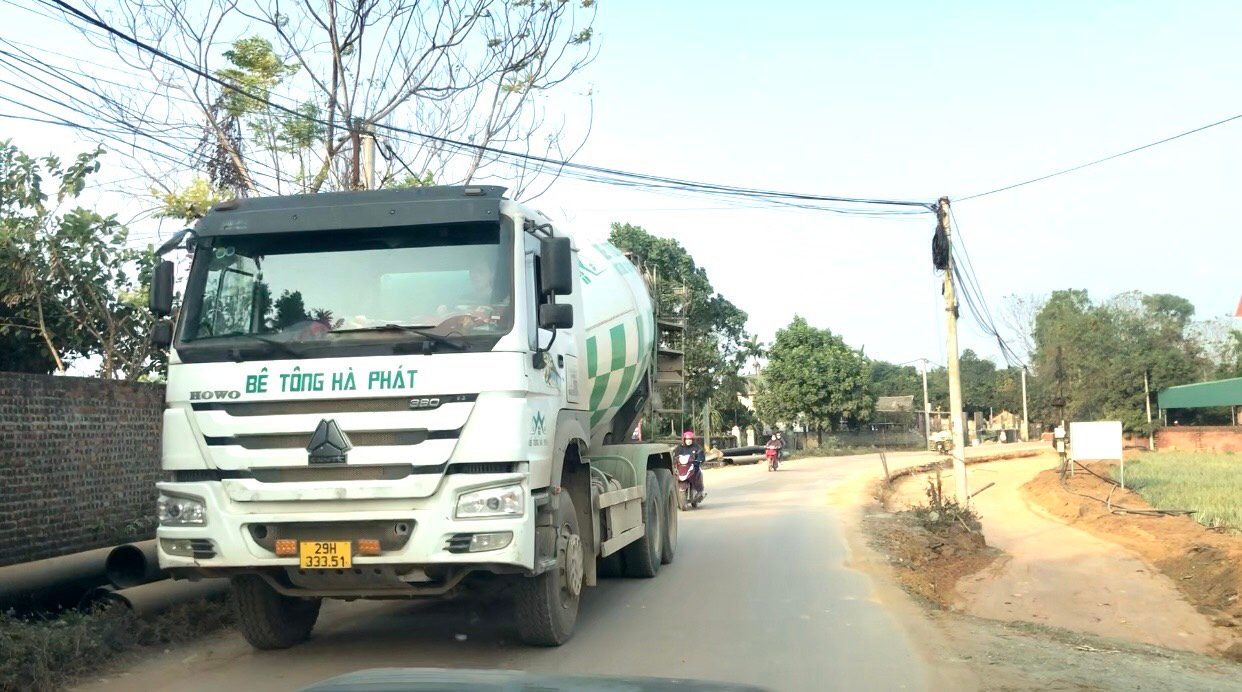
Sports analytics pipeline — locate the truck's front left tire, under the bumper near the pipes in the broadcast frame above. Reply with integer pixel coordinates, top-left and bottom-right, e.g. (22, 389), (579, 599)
(230, 574), (319, 650)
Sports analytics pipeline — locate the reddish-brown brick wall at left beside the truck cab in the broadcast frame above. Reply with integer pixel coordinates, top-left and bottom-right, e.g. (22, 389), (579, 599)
(0, 373), (164, 565)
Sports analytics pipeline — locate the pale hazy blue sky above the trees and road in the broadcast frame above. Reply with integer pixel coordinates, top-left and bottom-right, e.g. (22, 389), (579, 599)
(0, 0), (1242, 363)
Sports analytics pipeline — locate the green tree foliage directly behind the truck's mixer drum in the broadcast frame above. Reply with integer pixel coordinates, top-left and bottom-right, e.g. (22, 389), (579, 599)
(609, 224), (749, 426)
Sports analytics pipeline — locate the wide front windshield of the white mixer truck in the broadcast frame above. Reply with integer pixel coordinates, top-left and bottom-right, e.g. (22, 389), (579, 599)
(179, 222), (513, 354)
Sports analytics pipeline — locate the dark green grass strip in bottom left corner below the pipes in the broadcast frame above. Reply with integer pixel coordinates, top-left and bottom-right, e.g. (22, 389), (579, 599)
(0, 601), (232, 692)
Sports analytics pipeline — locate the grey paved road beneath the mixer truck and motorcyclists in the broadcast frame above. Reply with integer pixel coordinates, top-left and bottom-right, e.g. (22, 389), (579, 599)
(72, 447), (1028, 692)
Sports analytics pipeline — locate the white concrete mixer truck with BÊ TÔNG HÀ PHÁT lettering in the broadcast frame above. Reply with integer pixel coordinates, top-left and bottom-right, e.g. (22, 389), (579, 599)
(150, 186), (677, 649)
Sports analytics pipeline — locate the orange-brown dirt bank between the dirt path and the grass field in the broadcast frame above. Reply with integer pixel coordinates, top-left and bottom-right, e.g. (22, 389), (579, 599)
(1022, 463), (1242, 660)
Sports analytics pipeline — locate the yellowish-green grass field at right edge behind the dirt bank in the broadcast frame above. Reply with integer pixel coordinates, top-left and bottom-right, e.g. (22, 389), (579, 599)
(1113, 452), (1242, 529)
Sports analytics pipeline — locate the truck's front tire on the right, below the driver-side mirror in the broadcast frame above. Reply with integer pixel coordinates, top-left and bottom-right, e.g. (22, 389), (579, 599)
(514, 493), (586, 646)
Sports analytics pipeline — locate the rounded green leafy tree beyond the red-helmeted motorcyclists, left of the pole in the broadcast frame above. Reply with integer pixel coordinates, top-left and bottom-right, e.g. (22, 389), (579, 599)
(755, 317), (876, 444)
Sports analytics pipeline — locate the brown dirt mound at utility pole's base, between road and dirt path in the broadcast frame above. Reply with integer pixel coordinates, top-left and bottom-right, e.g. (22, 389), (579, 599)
(863, 507), (1002, 608)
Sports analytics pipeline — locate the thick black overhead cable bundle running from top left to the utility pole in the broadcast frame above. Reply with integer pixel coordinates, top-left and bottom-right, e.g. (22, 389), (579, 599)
(42, 0), (934, 215)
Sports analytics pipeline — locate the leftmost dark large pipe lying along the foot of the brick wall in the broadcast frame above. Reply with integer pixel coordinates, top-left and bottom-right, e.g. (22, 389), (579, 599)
(0, 548), (112, 611)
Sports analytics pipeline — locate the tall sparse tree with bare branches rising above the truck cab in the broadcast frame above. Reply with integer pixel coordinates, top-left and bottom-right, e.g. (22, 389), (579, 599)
(75, 0), (597, 198)
